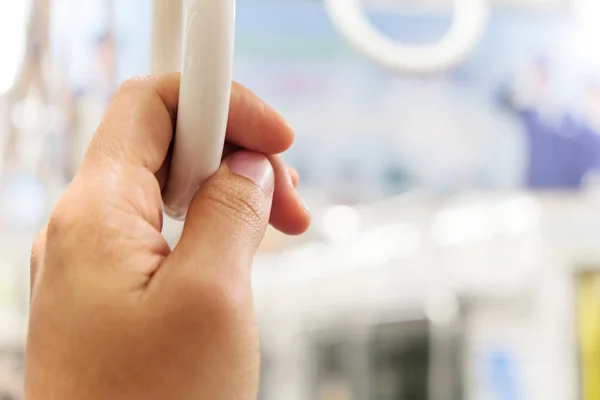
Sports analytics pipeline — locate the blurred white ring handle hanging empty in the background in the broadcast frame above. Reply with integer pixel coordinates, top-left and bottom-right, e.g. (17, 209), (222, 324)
(325, 0), (490, 74)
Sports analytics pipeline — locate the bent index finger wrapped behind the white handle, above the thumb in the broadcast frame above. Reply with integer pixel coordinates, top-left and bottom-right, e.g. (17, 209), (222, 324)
(83, 73), (294, 177)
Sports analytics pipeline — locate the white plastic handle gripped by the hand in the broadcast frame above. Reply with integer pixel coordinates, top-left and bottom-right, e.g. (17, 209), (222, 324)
(152, 0), (235, 219)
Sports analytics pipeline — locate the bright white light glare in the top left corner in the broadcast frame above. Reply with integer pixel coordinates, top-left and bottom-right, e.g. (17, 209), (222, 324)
(0, 0), (30, 96)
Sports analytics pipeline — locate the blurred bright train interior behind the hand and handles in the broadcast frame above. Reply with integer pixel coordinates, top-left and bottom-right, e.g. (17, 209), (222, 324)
(0, 0), (600, 400)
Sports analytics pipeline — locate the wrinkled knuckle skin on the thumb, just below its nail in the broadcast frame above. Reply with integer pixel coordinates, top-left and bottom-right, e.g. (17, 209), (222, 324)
(207, 184), (266, 229)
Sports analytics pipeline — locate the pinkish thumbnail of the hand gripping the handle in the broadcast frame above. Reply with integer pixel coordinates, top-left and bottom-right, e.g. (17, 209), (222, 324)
(227, 151), (275, 193)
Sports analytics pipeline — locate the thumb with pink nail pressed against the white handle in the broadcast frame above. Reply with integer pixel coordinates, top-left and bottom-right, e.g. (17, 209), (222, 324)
(171, 150), (275, 272)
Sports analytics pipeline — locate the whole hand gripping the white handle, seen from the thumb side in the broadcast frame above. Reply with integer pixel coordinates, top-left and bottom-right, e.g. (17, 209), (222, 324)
(26, 74), (310, 400)
